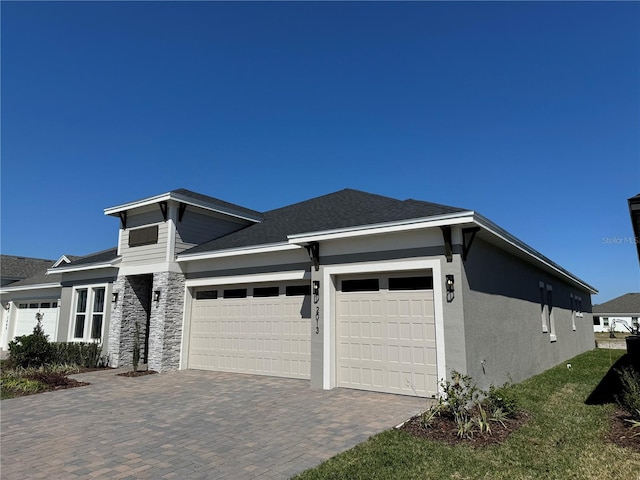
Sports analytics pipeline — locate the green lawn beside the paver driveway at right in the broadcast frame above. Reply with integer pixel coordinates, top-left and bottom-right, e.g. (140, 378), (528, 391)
(295, 349), (640, 480)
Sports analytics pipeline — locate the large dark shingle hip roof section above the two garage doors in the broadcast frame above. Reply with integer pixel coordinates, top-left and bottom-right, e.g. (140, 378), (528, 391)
(183, 189), (466, 254)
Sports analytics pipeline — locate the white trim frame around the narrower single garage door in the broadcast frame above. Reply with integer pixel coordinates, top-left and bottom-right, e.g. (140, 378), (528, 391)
(320, 259), (447, 390)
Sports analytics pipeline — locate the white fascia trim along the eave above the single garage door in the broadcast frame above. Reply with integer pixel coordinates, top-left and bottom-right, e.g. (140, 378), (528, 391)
(287, 211), (474, 244)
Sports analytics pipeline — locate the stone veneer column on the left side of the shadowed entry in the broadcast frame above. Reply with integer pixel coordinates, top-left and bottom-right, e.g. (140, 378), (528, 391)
(107, 275), (151, 367)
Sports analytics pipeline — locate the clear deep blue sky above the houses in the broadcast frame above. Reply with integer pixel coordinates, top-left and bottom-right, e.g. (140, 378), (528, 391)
(0, 1), (640, 303)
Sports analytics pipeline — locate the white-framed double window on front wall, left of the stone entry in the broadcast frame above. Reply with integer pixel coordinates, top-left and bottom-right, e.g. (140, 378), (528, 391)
(73, 287), (106, 341)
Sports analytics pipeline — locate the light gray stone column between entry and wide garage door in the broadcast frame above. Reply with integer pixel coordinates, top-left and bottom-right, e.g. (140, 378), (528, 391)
(149, 272), (185, 372)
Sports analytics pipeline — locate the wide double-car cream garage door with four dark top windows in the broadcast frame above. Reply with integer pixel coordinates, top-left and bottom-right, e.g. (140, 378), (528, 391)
(189, 284), (311, 379)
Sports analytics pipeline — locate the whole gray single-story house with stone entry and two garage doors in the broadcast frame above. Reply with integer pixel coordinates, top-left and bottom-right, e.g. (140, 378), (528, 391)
(0, 189), (597, 396)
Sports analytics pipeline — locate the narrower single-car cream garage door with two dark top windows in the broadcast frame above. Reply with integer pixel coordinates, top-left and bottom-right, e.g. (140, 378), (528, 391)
(336, 273), (438, 396)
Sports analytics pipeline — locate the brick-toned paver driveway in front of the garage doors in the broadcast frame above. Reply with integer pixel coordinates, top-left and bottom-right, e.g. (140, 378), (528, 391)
(0, 370), (424, 480)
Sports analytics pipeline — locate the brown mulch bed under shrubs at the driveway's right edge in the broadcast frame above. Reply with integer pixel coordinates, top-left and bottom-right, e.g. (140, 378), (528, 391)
(400, 412), (529, 447)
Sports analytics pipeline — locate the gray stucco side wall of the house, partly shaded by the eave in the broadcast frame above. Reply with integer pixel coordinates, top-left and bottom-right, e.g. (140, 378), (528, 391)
(462, 239), (594, 388)
